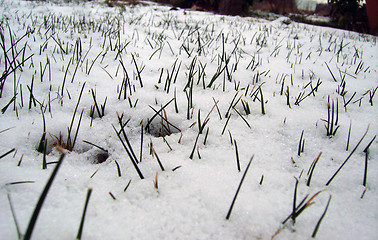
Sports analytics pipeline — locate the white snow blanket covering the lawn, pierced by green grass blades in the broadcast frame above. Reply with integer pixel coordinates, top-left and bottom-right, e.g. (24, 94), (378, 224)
(0, 0), (378, 239)
